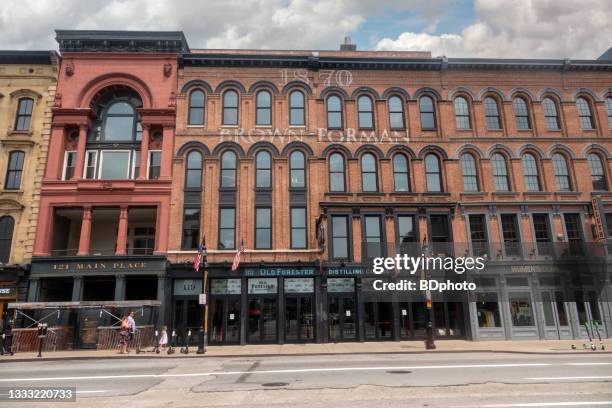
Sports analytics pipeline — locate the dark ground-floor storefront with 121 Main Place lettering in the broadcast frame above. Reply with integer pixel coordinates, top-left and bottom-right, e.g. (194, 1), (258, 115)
(27, 255), (166, 348)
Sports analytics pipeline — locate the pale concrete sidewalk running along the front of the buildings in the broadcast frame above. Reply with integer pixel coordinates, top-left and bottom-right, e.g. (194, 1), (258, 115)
(0, 339), (612, 363)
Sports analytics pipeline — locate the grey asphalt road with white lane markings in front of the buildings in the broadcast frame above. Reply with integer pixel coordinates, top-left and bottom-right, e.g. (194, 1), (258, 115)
(0, 353), (612, 408)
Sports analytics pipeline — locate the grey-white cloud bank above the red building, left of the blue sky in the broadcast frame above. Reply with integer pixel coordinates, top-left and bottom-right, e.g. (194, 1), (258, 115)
(0, 0), (452, 49)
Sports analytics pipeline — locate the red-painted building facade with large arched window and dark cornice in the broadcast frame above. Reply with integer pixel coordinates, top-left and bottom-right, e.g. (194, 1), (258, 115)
(28, 31), (186, 346)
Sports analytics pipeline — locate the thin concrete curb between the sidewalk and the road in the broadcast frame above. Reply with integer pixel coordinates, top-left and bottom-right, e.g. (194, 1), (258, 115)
(0, 350), (612, 364)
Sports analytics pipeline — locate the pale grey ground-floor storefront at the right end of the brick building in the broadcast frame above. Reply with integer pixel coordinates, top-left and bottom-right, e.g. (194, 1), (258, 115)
(470, 264), (611, 340)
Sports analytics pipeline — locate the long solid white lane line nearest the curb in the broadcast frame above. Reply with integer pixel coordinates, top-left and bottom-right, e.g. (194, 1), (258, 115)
(0, 363), (554, 382)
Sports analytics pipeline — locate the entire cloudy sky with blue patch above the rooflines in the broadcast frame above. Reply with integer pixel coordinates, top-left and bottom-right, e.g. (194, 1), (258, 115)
(0, 0), (612, 58)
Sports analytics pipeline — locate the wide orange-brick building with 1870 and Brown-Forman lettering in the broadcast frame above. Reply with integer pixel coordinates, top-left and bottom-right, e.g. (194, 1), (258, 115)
(166, 50), (612, 344)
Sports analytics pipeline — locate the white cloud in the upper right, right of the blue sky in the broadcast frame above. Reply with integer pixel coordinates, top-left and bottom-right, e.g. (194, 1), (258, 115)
(376, 0), (612, 59)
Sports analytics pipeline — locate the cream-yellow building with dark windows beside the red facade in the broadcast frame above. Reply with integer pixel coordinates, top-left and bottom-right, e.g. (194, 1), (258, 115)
(0, 51), (58, 318)
